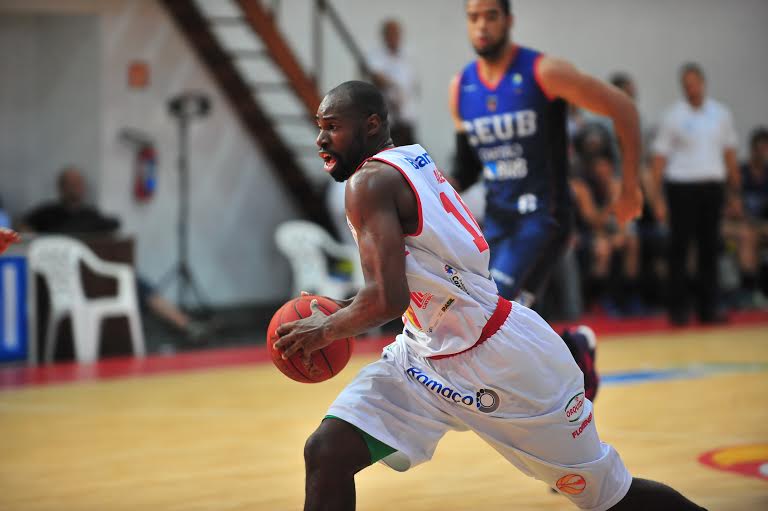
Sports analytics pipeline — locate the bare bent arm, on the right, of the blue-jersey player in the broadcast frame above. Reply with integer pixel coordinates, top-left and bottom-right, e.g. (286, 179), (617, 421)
(538, 57), (643, 224)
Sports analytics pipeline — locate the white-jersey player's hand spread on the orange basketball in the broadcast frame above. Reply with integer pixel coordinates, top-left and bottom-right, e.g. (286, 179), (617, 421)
(274, 300), (333, 376)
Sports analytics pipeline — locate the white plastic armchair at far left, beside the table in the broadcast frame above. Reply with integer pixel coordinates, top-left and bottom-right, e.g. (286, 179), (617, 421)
(29, 236), (146, 363)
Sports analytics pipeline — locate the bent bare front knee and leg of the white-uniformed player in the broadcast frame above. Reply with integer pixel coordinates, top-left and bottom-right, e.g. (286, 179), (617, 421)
(304, 419), (371, 511)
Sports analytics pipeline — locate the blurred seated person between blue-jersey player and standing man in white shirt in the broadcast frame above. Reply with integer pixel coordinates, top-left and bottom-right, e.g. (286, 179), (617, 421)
(571, 155), (642, 314)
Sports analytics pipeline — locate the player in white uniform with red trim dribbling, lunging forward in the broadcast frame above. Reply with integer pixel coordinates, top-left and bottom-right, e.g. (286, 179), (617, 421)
(275, 82), (701, 511)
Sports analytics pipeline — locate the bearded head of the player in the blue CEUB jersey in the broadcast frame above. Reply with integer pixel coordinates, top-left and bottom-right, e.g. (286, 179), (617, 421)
(466, 0), (514, 60)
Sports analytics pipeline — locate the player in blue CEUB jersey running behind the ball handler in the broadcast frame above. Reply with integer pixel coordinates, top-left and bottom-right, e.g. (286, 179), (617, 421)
(450, 0), (642, 399)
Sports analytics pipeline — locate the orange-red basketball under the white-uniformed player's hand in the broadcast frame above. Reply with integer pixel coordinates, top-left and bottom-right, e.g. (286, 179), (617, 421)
(267, 295), (355, 383)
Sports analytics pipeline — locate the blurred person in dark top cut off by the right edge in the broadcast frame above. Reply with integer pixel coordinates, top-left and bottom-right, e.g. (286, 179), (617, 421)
(723, 127), (768, 307)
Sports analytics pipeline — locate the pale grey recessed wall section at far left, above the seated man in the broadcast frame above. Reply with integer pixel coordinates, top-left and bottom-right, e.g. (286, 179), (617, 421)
(0, 14), (101, 212)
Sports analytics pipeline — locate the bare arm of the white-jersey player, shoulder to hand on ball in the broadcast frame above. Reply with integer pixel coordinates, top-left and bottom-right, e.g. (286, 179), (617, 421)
(275, 161), (418, 359)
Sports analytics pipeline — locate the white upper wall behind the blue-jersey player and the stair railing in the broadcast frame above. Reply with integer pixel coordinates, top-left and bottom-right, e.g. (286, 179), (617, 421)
(280, 0), (768, 166)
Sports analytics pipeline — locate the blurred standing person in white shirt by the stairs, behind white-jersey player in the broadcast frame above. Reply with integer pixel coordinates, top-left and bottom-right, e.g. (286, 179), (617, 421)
(368, 19), (419, 146)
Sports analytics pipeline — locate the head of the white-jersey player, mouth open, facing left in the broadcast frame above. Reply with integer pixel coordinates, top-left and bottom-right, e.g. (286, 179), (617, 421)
(316, 81), (391, 182)
